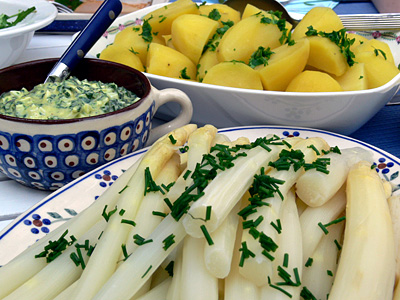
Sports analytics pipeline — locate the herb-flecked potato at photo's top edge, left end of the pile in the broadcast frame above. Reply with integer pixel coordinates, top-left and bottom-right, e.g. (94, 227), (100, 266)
(143, 0), (199, 35)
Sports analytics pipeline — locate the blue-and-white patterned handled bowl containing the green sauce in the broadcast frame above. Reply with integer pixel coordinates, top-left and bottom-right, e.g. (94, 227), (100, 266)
(0, 59), (192, 190)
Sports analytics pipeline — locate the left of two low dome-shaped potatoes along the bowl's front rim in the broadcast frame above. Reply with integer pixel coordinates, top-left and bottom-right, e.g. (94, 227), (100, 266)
(203, 62), (263, 90)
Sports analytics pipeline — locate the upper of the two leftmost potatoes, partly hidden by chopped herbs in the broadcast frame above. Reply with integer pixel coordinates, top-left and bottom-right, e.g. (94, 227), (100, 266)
(114, 26), (164, 64)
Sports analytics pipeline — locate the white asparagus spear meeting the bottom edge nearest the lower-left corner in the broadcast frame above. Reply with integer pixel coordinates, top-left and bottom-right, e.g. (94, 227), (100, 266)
(3, 220), (106, 300)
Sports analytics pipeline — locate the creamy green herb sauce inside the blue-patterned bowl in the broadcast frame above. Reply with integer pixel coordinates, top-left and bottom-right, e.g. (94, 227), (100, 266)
(0, 76), (140, 120)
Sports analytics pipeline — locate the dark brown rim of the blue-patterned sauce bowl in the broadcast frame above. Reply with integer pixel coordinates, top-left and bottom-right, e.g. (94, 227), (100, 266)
(0, 58), (152, 125)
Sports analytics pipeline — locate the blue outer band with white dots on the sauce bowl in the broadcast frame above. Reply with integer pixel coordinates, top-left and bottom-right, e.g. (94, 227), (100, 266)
(0, 103), (155, 190)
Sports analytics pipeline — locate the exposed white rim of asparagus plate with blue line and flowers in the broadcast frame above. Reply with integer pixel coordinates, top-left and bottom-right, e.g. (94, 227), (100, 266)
(0, 126), (400, 266)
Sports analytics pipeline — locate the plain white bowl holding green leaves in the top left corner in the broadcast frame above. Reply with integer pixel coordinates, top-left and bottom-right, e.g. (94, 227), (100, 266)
(0, 0), (57, 69)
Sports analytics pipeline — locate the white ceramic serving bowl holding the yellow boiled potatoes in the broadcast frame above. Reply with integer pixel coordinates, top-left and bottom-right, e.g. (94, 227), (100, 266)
(89, 4), (400, 134)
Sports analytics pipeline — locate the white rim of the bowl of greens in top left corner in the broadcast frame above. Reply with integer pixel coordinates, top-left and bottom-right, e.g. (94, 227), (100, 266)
(0, 0), (57, 38)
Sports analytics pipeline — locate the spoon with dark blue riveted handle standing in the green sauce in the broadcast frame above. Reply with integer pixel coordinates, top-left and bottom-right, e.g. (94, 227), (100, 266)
(45, 0), (122, 82)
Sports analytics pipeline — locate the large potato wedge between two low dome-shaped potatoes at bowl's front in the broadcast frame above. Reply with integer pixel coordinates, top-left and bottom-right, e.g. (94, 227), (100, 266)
(257, 38), (310, 91)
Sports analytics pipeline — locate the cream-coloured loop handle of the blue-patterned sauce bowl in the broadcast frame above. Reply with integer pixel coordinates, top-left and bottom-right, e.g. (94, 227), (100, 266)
(146, 87), (193, 145)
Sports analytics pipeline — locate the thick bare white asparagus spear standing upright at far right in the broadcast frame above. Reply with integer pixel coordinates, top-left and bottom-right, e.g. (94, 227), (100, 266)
(329, 162), (396, 300)
